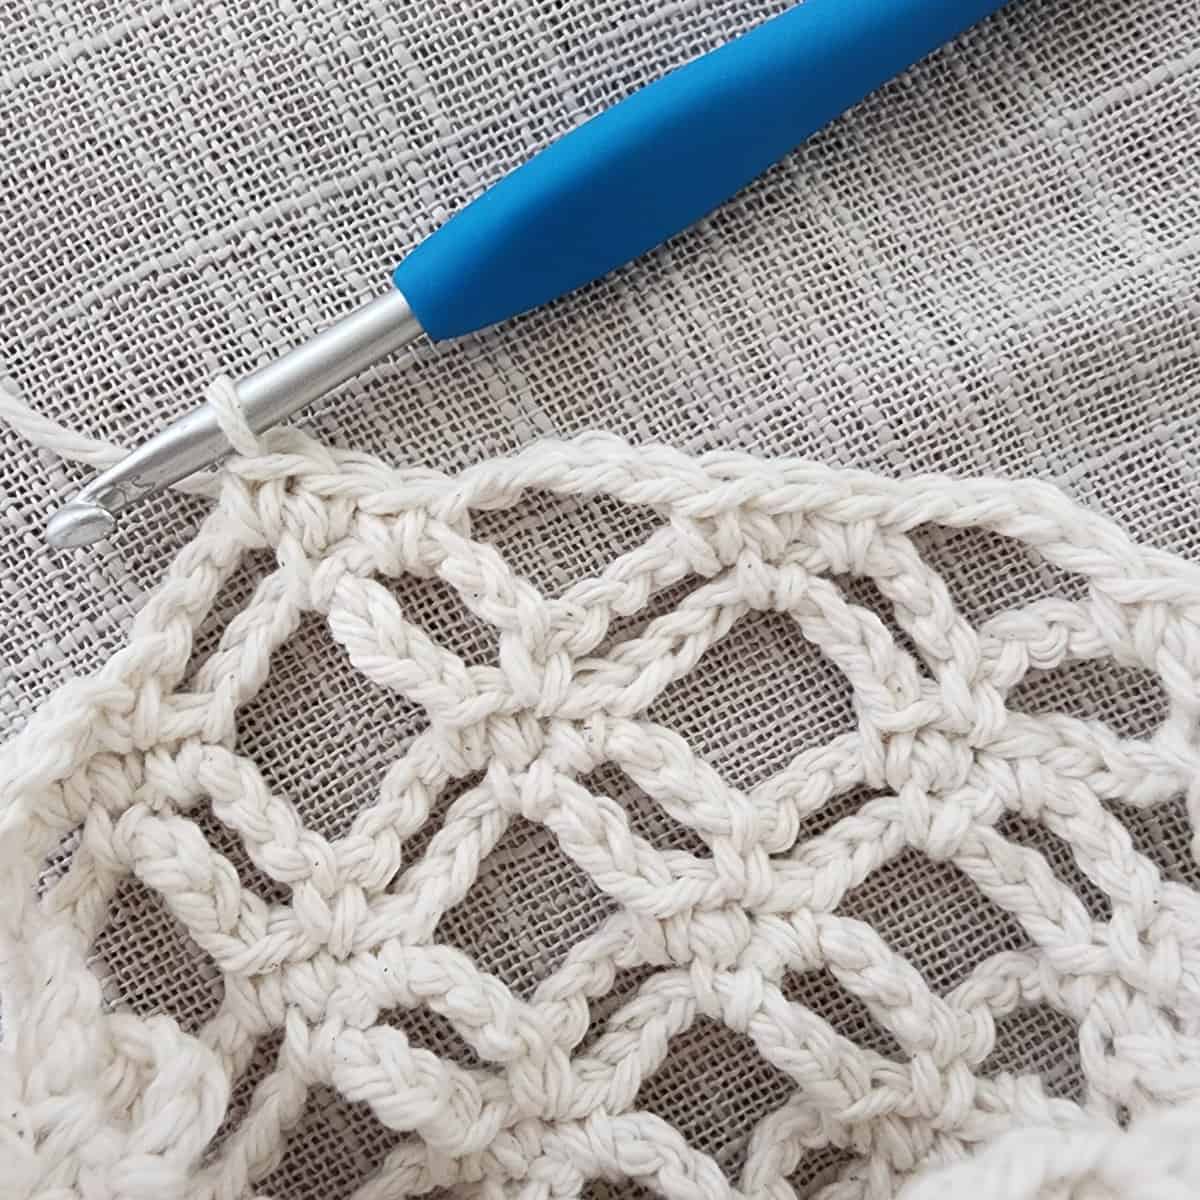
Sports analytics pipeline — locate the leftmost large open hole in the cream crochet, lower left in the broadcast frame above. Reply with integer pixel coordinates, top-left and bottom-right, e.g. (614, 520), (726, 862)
(90, 876), (224, 1033)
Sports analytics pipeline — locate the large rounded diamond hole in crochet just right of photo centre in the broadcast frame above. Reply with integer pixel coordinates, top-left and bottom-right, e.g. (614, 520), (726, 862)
(648, 612), (857, 787)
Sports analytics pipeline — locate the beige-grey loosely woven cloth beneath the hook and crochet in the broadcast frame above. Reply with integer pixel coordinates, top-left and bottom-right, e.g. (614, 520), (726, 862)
(0, 0), (1200, 1200)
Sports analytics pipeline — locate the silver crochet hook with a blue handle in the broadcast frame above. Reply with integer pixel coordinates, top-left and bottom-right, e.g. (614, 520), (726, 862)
(47, 0), (1006, 547)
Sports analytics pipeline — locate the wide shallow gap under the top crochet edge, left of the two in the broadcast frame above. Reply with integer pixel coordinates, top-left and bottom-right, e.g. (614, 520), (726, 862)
(470, 492), (665, 596)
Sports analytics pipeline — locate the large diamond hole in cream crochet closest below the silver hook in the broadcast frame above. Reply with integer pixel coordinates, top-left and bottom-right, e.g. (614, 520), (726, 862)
(238, 614), (427, 838)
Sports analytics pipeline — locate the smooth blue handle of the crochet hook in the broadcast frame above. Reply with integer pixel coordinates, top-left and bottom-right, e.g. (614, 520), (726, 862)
(392, 0), (1004, 340)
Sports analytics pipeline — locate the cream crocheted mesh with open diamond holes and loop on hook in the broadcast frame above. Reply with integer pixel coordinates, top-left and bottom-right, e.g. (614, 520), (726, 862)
(0, 385), (1200, 1200)
